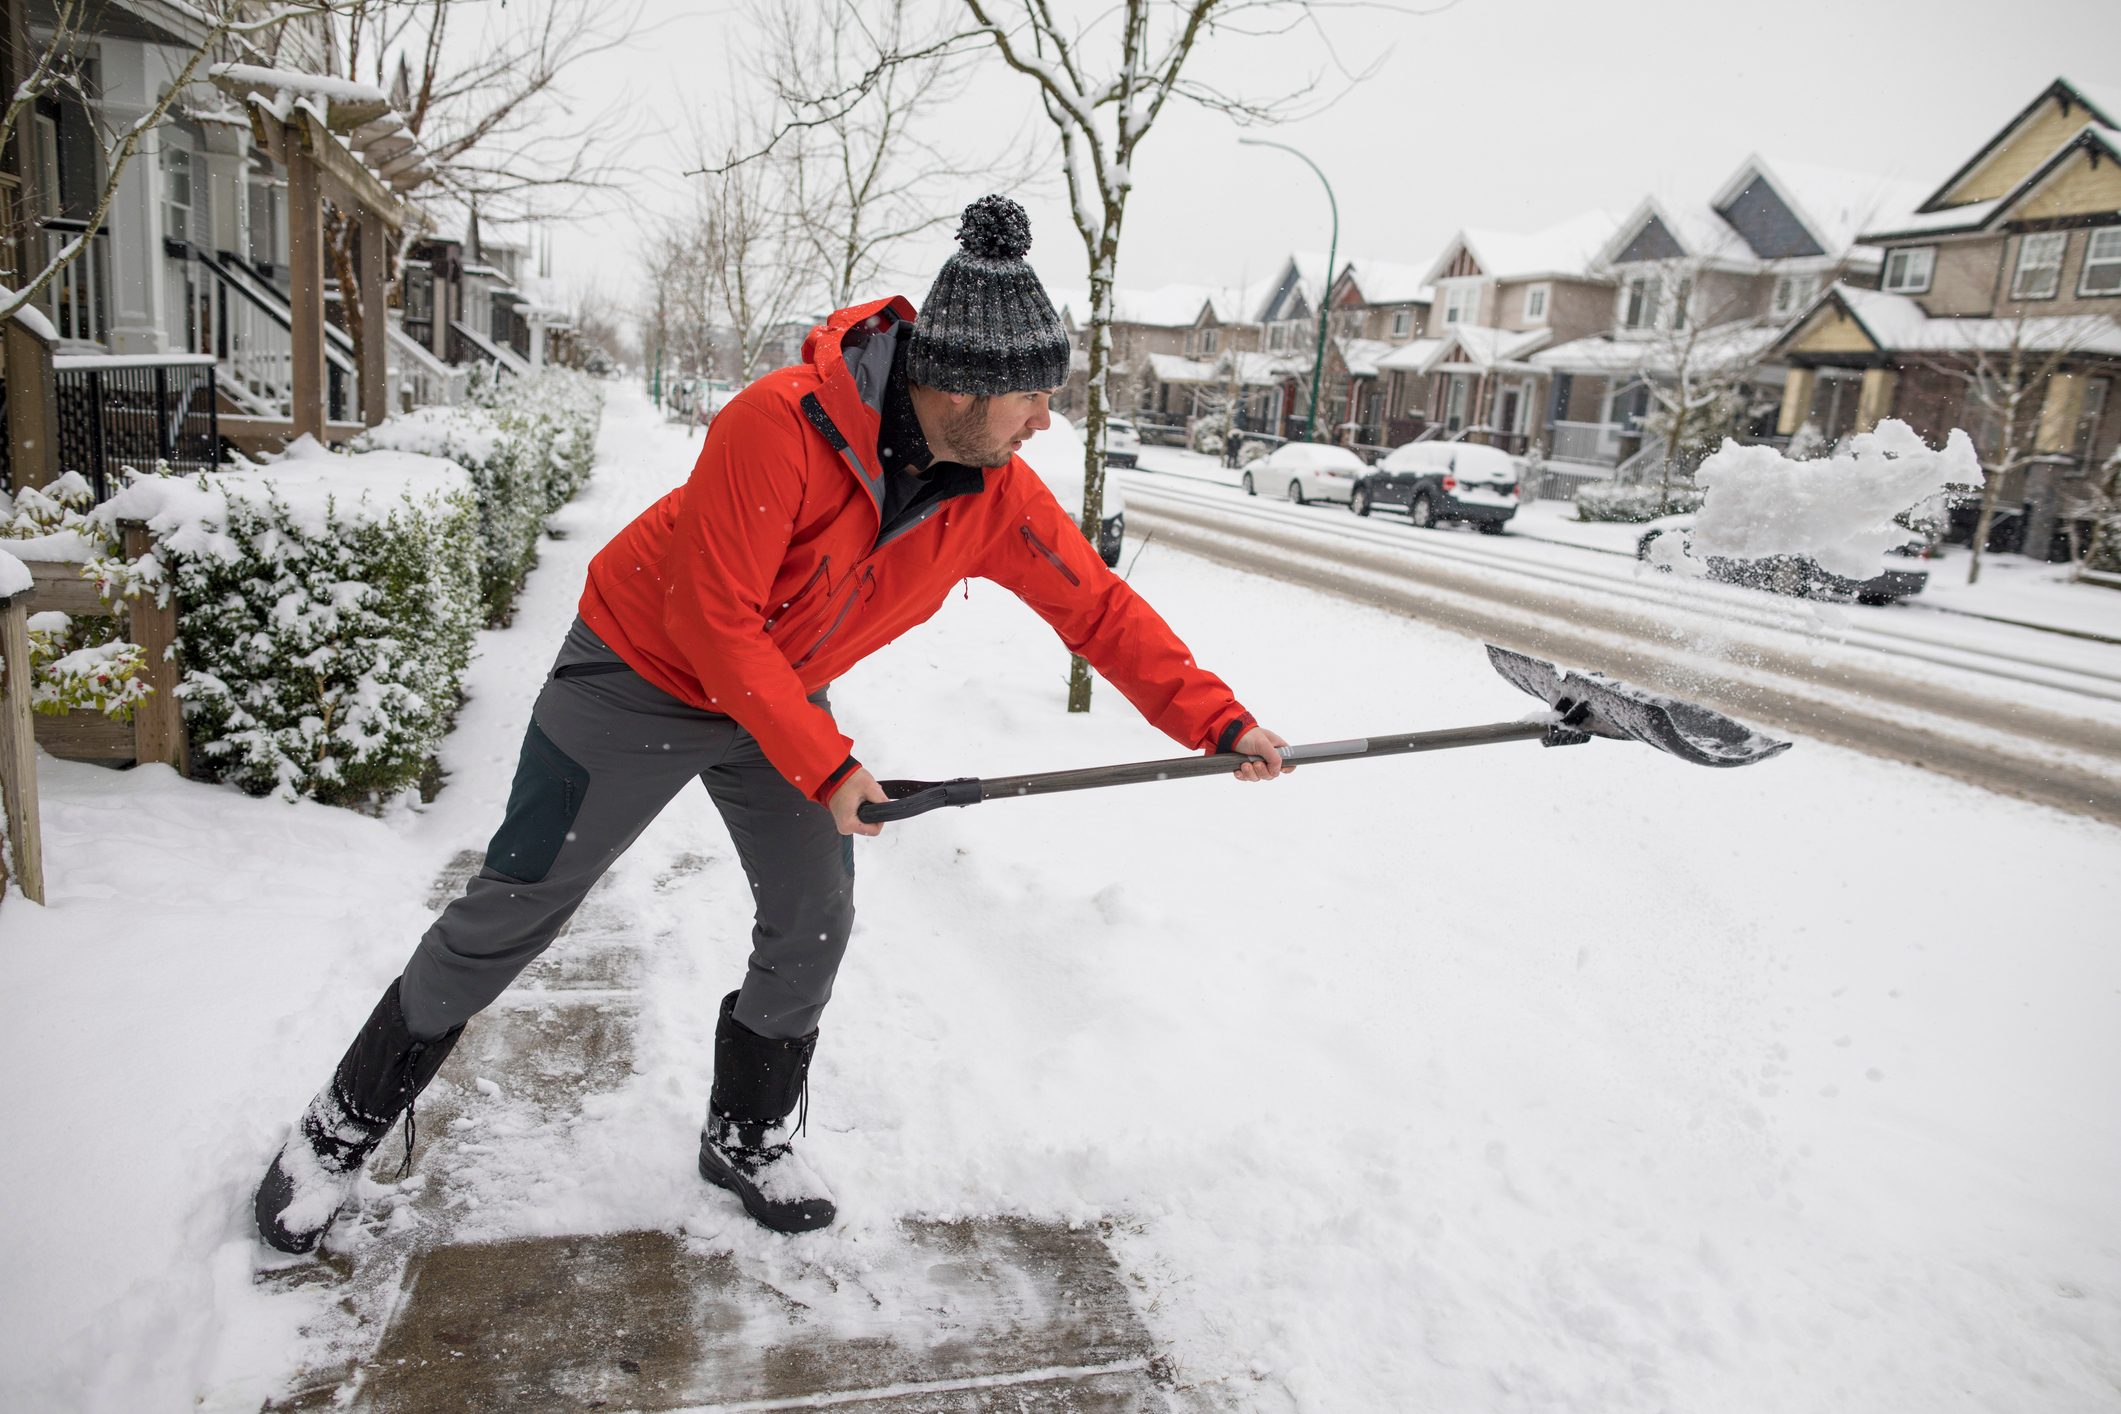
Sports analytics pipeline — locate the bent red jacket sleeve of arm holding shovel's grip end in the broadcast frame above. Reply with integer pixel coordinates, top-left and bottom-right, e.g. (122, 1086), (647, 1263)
(662, 399), (857, 801)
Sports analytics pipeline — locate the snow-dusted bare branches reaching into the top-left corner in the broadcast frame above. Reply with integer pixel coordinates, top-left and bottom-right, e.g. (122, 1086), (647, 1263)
(0, 0), (329, 318)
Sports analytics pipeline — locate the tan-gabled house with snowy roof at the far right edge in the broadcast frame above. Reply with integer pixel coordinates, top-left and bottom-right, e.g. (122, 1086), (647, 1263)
(1769, 78), (2121, 558)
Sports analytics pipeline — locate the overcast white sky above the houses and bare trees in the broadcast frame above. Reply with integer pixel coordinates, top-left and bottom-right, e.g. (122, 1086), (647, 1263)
(530, 0), (2121, 324)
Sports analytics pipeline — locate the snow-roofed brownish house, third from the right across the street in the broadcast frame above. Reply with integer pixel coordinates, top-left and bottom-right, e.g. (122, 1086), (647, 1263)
(1377, 210), (1618, 452)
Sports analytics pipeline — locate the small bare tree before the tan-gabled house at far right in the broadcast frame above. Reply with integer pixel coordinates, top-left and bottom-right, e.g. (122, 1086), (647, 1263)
(1920, 314), (2106, 585)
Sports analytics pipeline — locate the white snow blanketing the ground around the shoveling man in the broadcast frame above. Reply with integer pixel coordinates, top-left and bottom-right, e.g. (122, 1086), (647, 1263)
(0, 392), (2121, 1414)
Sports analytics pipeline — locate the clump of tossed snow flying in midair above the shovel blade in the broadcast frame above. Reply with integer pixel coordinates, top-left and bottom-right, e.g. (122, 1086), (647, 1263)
(1652, 418), (1981, 579)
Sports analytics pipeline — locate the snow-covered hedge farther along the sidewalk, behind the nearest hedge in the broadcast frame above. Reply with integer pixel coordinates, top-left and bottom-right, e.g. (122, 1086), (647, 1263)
(354, 369), (604, 623)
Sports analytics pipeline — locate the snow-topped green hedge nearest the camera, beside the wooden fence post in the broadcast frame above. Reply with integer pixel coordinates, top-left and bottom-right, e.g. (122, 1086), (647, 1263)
(106, 439), (486, 806)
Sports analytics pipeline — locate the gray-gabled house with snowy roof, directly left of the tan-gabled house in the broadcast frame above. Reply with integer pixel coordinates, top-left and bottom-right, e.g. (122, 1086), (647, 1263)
(1531, 155), (1913, 473)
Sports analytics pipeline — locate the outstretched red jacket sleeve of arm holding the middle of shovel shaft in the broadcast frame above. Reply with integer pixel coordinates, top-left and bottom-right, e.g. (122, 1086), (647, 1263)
(980, 472), (1256, 750)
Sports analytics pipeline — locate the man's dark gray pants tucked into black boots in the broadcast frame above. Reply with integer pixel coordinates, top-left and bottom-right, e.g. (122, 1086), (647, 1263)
(399, 619), (855, 1039)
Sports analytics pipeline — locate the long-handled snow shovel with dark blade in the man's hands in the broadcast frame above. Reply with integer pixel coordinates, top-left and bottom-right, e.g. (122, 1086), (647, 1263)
(855, 644), (1790, 825)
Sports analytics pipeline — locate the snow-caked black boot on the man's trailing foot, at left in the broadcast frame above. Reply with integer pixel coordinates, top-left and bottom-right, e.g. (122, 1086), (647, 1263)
(255, 982), (464, 1253)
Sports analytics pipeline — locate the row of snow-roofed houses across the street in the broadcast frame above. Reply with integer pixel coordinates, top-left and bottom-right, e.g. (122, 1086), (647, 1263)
(1065, 78), (2121, 553)
